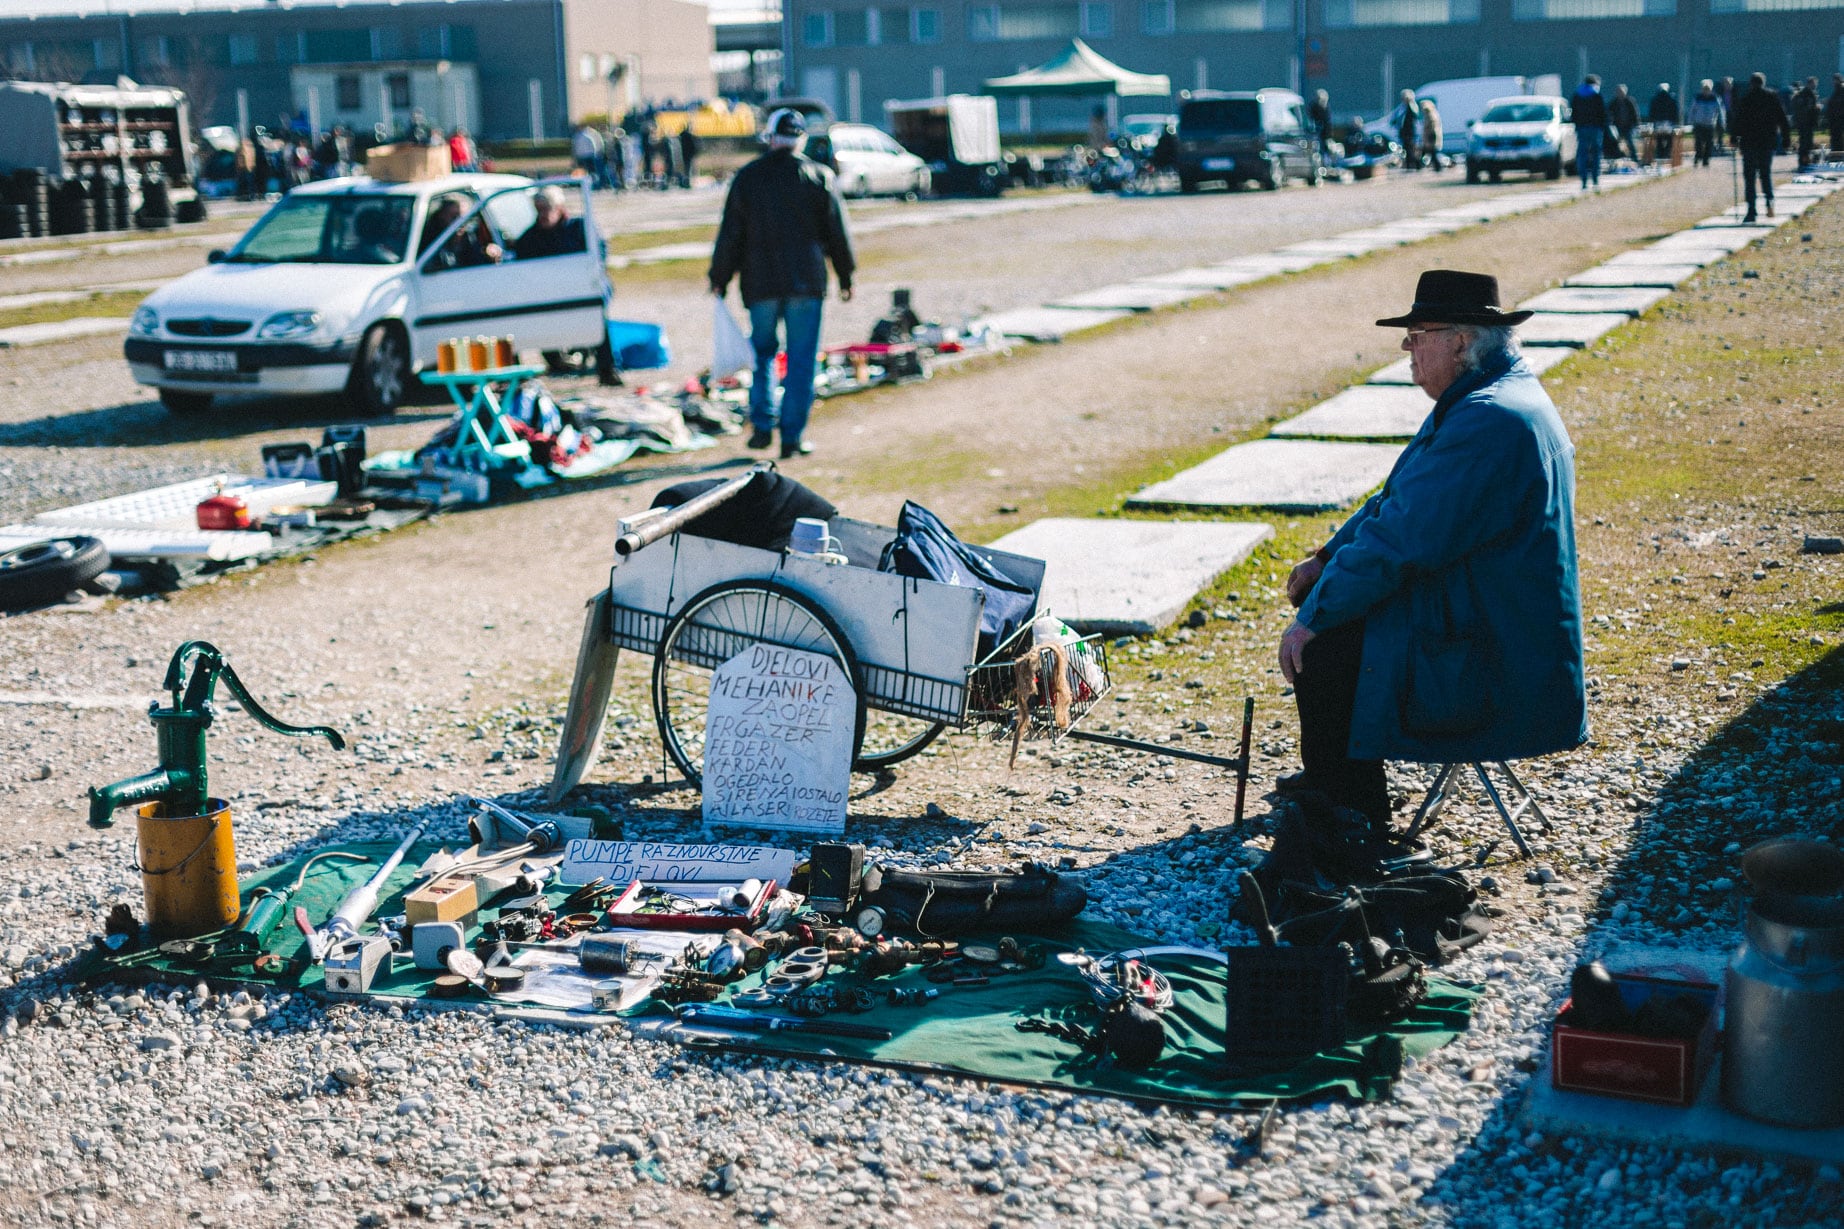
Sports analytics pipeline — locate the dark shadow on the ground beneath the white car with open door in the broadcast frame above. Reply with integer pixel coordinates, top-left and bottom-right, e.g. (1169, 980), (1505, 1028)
(0, 397), (454, 448)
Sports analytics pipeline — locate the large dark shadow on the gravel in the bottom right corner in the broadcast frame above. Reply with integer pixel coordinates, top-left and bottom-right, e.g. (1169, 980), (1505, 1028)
(1424, 648), (1844, 1229)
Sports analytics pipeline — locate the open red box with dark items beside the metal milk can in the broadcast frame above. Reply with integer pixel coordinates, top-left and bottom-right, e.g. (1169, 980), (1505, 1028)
(1549, 972), (1717, 1105)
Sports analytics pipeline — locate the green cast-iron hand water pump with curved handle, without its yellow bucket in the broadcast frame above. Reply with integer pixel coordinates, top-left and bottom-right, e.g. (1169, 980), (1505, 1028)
(90, 640), (345, 829)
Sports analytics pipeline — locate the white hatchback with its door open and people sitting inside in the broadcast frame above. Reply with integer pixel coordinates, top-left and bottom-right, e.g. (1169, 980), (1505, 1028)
(124, 175), (614, 413)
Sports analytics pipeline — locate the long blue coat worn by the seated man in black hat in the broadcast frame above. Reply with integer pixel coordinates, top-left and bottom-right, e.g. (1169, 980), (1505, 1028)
(1300, 348), (1588, 764)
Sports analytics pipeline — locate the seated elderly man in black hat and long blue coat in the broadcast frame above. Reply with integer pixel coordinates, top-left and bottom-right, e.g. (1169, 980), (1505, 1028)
(1280, 269), (1588, 834)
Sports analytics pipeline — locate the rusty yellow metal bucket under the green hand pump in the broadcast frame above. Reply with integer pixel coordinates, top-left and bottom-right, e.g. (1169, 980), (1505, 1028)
(135, 797), (238, 939)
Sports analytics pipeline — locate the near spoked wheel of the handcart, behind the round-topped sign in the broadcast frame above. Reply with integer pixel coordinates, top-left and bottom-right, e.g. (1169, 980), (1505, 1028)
(653, 581), (866, 784)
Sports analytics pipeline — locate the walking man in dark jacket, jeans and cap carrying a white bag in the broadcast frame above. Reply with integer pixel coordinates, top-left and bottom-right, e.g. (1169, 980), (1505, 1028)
(710, 107), (856, 458)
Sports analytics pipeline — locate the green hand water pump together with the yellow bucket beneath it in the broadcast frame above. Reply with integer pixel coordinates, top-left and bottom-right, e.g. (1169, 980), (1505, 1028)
(90, 640), (345, 939)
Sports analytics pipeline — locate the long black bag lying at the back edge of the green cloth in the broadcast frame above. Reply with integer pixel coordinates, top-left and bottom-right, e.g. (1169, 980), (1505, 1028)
(861, 862), (1088, 937)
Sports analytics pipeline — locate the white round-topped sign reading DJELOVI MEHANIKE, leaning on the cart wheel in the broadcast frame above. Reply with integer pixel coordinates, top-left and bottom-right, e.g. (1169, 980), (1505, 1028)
(704, 644), (857, 832)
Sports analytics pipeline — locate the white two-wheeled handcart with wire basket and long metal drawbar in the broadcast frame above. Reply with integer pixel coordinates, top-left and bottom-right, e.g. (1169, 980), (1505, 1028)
(551, 474), (1252, 817)
